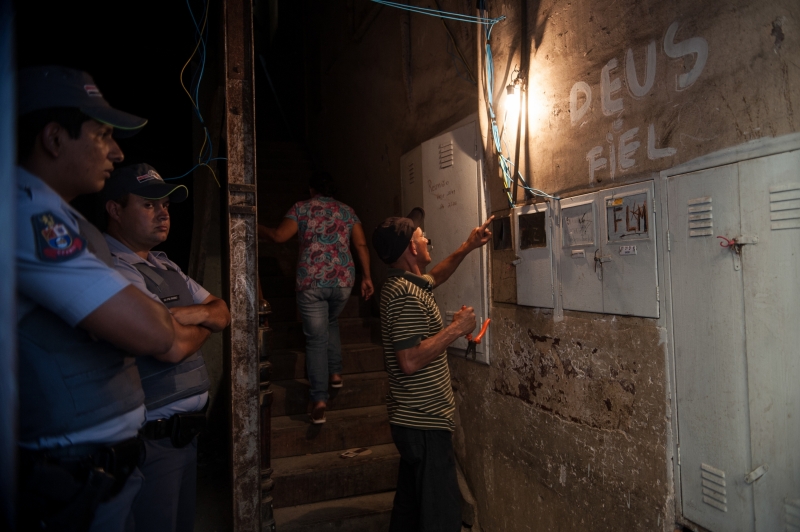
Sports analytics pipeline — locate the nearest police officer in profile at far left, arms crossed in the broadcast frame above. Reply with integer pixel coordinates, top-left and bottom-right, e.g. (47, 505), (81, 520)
(16, 67), (174, 532)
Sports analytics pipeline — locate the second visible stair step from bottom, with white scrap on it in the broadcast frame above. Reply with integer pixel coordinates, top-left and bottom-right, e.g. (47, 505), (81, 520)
(272, 443), (400, 508)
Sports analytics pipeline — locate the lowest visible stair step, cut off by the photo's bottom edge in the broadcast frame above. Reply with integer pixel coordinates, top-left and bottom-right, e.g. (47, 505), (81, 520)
(275, 491), (394, 532)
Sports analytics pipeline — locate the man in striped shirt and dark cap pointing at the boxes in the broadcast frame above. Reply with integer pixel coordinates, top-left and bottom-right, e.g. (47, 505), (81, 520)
(372, 208), (493, 532)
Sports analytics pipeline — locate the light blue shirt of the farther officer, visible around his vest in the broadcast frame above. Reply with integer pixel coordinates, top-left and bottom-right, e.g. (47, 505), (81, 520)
(103, 234), (211, 421)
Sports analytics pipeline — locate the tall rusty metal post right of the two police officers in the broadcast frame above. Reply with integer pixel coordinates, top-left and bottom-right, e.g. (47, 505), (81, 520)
(222, 0), (261, 532)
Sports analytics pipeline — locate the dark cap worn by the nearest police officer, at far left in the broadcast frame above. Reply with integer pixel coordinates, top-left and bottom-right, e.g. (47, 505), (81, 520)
(17, 66), (147, 138)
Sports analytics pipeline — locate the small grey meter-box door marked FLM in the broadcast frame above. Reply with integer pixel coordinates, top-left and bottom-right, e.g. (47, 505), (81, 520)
(598, 181), (659, 318)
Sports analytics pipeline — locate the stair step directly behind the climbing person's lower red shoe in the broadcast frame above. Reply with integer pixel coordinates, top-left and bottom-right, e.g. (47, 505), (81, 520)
(271, 371), (389, 417)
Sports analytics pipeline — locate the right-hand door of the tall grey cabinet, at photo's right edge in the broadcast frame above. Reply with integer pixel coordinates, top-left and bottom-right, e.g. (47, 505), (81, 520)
(736, 151), (800, 532)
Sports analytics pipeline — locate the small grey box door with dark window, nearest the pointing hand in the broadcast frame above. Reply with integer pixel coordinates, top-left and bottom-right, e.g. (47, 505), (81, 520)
(514, 203), (555, 308)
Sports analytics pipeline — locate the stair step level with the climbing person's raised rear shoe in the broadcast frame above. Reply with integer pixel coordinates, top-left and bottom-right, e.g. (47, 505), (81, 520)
(270, 344), (384, 382)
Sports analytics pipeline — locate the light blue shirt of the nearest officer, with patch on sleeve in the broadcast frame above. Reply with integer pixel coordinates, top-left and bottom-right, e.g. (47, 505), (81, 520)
(16, 167), (144, 448)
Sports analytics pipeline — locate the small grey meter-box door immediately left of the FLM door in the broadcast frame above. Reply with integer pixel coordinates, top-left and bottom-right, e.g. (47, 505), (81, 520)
(559, 193), (603, 312)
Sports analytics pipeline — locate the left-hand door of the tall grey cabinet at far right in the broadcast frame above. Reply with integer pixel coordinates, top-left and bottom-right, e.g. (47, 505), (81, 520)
(667, 165), (753, 532)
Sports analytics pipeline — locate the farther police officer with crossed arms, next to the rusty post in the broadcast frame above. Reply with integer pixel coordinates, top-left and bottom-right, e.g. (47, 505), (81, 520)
(103, 164), (230, 532)
